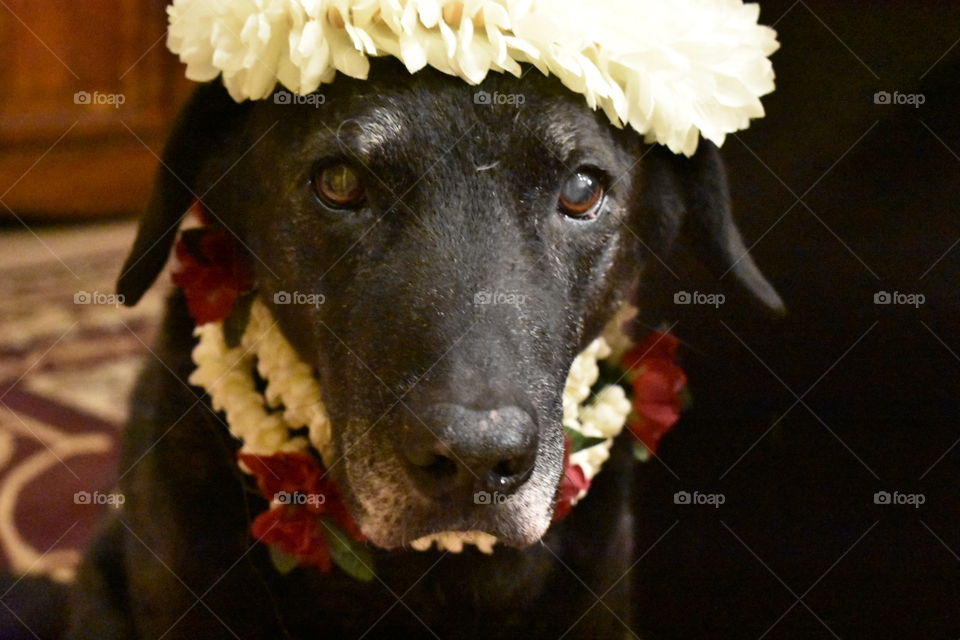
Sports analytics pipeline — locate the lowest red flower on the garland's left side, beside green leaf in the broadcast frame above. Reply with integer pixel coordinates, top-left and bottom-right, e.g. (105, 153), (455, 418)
(251, 506), (331, 571)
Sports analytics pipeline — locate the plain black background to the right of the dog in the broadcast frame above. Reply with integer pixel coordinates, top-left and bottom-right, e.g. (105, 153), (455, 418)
(632, 0), (960, 638)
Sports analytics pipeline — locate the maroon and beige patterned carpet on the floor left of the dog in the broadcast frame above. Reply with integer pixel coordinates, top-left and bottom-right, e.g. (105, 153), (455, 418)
(0, 223), (169, 580)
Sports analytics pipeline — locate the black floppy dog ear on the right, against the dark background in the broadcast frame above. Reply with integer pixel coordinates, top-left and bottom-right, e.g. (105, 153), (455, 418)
(643, 140), (784, 313)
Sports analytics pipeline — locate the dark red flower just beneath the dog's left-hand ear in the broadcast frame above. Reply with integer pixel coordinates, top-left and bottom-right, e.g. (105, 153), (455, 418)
(173, 221), (253, 324)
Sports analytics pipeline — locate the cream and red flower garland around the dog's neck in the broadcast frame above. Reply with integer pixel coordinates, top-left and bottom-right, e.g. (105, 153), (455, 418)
(173, 215), (687, 580)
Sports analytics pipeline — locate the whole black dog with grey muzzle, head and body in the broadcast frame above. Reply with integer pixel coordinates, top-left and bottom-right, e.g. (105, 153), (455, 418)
(15, 61), (780, 639)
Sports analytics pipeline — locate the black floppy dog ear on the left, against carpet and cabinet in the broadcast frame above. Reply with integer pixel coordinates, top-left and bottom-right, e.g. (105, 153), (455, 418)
(117, 80), (245, 306)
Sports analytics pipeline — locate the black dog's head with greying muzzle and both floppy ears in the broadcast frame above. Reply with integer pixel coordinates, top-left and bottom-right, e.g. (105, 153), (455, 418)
(119, 60), (780, 548)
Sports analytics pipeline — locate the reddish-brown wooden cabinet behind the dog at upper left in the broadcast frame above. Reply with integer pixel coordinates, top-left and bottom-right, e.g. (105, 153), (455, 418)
(0, 0), (191, 220)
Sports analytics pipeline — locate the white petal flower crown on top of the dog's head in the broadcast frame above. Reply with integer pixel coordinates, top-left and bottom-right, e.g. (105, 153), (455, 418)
(167, 0), (779, 155)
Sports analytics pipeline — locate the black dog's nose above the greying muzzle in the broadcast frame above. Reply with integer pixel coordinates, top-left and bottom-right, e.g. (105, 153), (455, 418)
(400, 404), (538, 497)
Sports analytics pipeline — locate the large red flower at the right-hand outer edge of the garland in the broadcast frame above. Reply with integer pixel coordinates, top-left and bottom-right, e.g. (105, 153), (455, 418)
(623, 331), (687, 454)
